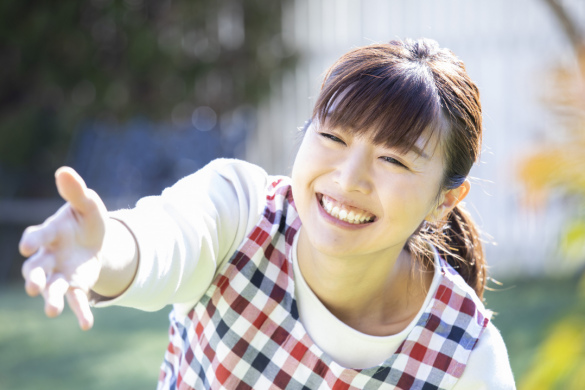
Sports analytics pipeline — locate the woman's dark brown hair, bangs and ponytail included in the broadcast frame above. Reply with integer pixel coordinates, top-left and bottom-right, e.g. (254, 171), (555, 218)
(313, 39), (486, 297)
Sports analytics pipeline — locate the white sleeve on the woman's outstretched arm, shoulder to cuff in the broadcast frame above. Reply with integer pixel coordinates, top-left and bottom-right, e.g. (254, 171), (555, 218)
(96, 159), (267, 313)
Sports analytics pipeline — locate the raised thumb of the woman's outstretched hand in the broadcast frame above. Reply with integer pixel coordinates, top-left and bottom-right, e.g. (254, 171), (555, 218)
(55, 167), (96, 214)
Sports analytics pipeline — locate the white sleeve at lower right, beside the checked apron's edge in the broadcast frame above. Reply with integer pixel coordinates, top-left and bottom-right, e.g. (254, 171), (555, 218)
(453, 322), (516, 390)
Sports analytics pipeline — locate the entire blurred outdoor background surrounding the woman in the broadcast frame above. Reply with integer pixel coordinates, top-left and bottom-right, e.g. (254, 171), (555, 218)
(0, 0), (585, 390)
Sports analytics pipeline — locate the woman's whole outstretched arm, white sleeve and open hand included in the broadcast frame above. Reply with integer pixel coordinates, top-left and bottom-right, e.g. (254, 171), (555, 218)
(20, 160), (267, 329)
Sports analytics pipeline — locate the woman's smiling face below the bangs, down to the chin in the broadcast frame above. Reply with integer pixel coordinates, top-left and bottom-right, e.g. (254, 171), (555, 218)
(292, 122), (443, 257)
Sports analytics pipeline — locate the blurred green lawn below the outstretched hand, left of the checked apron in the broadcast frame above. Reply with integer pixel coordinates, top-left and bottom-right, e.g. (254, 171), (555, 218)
(0, 286), (170, 390)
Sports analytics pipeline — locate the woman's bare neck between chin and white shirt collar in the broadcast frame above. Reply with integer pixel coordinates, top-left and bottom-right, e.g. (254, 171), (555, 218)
(297, 230), (433, 336)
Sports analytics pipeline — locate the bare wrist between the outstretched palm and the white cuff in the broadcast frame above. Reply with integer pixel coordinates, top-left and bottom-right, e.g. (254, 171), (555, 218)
(92, 218), (138, 298)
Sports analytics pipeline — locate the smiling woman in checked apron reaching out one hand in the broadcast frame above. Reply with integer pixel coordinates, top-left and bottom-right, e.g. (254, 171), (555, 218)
(20, 40), (514, 390)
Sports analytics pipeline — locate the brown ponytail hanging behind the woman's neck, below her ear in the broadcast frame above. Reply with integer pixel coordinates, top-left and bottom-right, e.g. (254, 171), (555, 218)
(408, 204), (487, 299)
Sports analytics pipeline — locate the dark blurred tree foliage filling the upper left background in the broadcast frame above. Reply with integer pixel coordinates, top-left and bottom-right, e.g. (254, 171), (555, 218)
(0, 0), (294, 196)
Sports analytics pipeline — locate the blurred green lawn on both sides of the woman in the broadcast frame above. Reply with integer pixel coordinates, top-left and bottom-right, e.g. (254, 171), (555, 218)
(0, 279), (585, 390)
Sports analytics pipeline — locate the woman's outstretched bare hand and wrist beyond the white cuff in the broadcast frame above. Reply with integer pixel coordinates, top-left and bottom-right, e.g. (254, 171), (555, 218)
(19, 168), (138, 329)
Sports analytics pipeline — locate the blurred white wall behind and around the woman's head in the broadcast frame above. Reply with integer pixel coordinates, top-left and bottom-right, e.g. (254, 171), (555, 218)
(246, 0), (585, 277)
